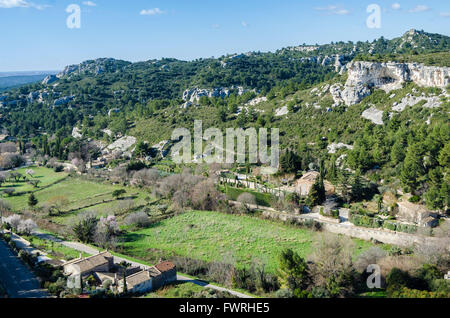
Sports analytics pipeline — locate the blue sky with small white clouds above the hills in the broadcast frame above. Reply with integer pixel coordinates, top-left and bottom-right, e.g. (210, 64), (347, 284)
(0, 0), (450, 72)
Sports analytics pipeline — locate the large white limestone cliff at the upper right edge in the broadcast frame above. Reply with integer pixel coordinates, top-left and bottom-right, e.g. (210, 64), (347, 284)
(330, 61), (450, 106)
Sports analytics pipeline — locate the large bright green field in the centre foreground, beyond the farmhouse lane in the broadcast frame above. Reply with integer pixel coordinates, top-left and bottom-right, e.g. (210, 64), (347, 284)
(119, 211), (372, 272)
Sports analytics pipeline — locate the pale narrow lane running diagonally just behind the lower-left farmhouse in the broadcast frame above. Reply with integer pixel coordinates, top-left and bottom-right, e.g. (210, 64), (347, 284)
(34, 232), (253, 298)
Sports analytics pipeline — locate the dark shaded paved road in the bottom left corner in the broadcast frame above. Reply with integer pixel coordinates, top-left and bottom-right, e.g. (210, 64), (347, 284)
(0, 240), (49, 298)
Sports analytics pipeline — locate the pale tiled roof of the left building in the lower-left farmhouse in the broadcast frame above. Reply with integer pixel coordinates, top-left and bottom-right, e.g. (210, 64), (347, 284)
(63, 252), (114, 276)
